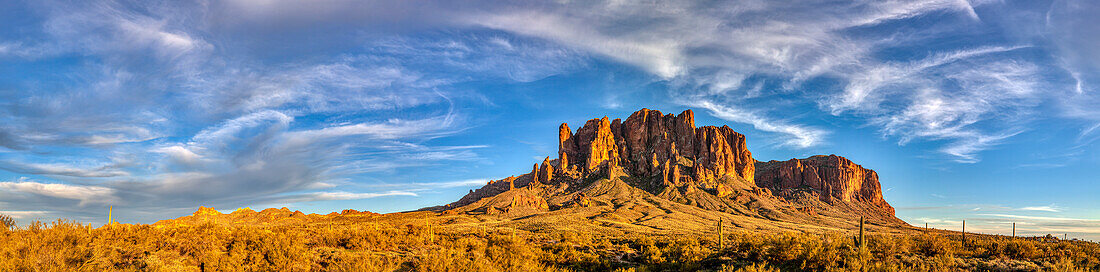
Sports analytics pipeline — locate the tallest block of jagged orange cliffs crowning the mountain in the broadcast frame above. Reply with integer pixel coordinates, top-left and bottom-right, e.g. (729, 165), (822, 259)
(558, 109), (756, 183)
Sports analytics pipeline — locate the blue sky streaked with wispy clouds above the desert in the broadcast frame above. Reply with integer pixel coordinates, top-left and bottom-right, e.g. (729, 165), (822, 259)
(0, 0), (1100, 240)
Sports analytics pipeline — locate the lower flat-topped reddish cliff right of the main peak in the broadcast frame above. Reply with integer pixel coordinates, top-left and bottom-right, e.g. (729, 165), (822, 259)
(756, 155), (894, 215)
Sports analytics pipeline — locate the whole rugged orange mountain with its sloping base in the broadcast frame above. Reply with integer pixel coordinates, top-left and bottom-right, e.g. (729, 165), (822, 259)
(427, 109), (908, 229)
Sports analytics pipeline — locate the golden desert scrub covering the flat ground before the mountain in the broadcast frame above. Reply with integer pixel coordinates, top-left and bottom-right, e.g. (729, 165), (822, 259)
(0, 209), (1100, 271)
